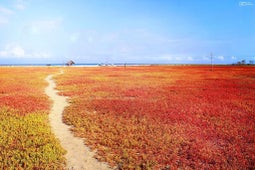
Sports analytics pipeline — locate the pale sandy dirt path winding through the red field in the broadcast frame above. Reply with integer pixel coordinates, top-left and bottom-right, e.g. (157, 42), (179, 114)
(45, 72), (110, 170)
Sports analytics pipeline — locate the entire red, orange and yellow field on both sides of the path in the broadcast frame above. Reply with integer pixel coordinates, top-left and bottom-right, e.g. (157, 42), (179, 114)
(0, 66), (255, 169)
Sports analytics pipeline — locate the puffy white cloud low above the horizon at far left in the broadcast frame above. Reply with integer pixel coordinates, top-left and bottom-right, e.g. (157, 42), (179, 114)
(0, 43), (50, 58)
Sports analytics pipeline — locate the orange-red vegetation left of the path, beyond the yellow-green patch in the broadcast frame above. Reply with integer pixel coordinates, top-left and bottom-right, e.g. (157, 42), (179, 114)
(0, 67), (56, 115)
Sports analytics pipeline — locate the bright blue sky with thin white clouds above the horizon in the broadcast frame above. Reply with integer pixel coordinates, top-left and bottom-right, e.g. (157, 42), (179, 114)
(0, 0), (255, 64)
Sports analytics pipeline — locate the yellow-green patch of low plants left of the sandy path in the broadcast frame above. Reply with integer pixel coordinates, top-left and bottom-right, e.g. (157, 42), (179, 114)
(0, 108), (65, 169)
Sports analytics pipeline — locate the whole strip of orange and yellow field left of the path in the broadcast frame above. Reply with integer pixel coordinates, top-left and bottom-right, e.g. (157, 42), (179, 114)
(0, 67), (65, 169)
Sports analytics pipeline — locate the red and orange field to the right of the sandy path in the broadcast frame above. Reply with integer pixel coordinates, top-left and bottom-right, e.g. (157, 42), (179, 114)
(56, 66), (255, 169)
